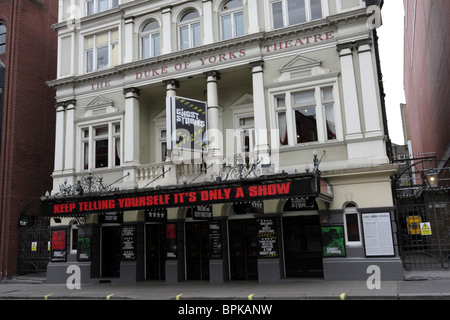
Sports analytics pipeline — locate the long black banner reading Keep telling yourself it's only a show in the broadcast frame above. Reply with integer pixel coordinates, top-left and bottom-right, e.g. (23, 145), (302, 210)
(41, 179), (315, 218)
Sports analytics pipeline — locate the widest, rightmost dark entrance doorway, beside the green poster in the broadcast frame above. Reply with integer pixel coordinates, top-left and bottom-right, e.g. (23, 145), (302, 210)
(283, 216), (323, 277)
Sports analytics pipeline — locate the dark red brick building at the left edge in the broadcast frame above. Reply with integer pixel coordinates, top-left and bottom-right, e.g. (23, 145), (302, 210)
(0, 0), (58, 281)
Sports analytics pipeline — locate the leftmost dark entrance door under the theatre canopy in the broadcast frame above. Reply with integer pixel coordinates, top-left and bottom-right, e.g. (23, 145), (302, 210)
(101, 226), (122, 278)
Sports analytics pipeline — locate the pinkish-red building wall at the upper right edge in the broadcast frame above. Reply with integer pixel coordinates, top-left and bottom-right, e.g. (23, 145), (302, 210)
(404, 0), (450, 166)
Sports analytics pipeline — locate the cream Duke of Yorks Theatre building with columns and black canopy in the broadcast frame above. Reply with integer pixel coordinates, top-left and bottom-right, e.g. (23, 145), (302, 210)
(42, 0), (403, 283)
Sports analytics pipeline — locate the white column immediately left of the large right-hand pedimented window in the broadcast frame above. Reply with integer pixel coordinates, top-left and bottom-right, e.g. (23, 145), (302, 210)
(250, 61), (270, 165)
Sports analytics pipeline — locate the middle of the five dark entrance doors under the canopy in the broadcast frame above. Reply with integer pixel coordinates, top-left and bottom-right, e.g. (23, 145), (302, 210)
(186, 222), (209, 280)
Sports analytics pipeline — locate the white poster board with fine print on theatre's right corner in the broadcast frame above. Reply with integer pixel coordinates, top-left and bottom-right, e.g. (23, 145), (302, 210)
(362, 212), (395, 257)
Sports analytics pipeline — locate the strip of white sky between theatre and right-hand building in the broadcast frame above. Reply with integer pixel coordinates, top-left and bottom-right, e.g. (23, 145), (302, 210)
(378, 0), (406, 145)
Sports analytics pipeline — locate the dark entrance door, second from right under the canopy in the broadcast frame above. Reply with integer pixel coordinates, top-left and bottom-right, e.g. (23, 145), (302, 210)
(228, 219), (258, 280)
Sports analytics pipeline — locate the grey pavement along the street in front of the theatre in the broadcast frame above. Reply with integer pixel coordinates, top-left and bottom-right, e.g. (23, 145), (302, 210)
(0, 270), (450, 301)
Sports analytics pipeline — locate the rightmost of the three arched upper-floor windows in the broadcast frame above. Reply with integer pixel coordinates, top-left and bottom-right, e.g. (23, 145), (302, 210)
(220, 0), (245, 40)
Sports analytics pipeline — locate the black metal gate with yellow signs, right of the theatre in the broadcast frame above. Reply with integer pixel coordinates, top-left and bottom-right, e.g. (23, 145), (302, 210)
(394, 157), (450, 270)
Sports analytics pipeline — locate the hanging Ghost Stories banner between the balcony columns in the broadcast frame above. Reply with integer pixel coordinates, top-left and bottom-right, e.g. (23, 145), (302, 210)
(166, 97), (208, 152)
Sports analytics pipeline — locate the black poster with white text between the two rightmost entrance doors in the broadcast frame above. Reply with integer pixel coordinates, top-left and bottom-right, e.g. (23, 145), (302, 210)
(256, 218), (279, 258)
